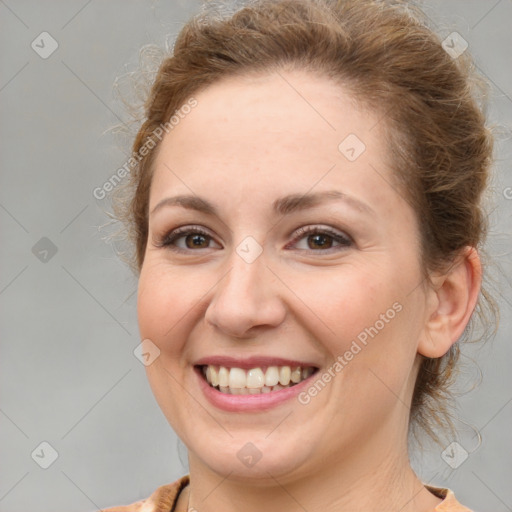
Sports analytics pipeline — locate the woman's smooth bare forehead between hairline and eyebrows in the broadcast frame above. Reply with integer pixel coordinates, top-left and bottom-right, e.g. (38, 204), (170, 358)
(151, 70), (396, 210)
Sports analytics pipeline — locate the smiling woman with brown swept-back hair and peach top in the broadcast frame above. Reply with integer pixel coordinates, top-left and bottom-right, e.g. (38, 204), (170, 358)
(103, 0), (492, 512)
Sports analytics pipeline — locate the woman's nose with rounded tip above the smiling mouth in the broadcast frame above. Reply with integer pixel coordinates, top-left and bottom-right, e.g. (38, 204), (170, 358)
(205, 252), (286, 338)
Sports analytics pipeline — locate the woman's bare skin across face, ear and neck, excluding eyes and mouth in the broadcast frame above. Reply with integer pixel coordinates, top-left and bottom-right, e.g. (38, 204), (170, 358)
(138, 70), (480, 512)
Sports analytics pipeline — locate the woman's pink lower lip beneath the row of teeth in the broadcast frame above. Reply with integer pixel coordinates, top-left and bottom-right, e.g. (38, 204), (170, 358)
(194, 368), (317, 412)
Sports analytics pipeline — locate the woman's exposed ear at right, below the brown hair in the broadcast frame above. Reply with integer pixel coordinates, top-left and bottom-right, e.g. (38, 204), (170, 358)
(418, 246), (482, 358)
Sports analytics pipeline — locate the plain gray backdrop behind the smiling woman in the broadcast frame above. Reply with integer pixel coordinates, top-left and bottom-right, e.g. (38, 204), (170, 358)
(0, 0), (512, 512)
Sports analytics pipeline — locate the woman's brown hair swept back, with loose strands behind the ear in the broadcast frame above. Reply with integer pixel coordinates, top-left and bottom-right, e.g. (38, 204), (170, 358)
(110, 0), (497, 439)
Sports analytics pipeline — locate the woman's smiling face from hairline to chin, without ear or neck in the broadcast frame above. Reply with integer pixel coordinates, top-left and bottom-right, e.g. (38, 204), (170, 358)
(138, 71), (427, 482)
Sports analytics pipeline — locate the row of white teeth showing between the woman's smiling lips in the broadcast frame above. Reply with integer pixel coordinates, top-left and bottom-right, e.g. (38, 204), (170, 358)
(197, 365), (318, 395)
